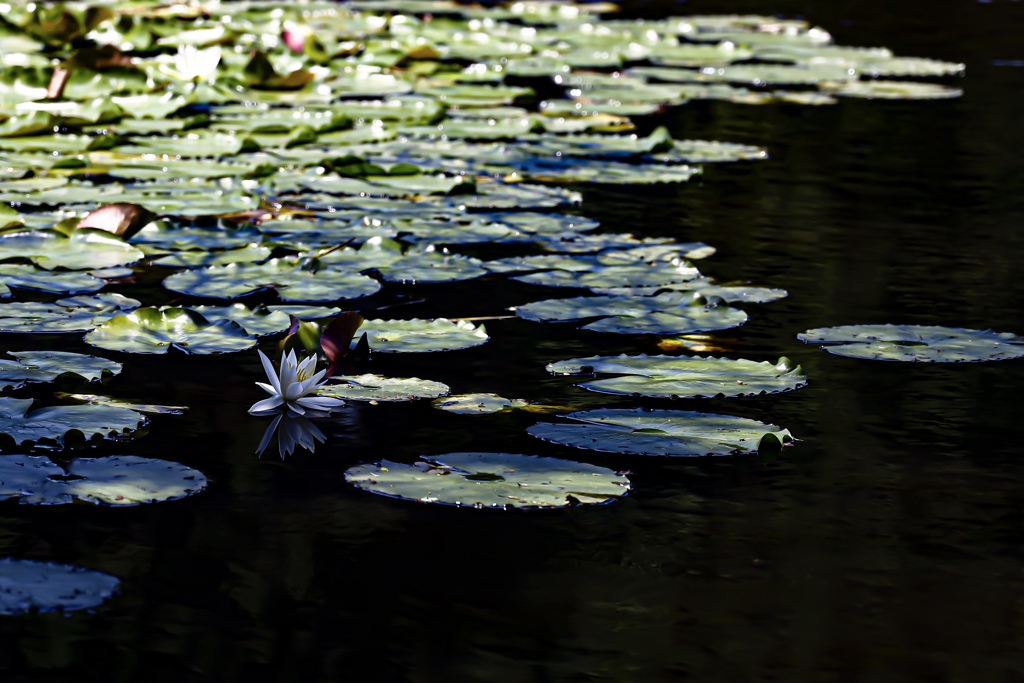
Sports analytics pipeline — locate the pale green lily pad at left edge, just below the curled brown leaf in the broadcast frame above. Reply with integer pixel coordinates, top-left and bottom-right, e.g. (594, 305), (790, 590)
(0, 229), (144, 270)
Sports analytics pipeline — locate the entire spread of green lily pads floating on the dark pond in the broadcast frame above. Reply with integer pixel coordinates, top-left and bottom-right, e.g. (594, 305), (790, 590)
(0, 0), (974, 613)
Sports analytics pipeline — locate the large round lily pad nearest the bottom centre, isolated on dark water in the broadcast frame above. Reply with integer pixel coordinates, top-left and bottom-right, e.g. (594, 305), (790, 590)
(345, 453), (631, 510)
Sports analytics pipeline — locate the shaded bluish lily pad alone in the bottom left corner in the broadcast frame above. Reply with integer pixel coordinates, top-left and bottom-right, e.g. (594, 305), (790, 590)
(0, 557), (121, 614)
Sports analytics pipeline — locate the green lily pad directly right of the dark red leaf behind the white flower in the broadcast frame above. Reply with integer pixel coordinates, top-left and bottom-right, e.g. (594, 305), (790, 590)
(352, 318), (489, 353)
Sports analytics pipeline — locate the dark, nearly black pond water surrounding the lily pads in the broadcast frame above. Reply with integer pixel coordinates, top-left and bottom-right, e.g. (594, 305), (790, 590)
(0, 0), (1024, 683)
